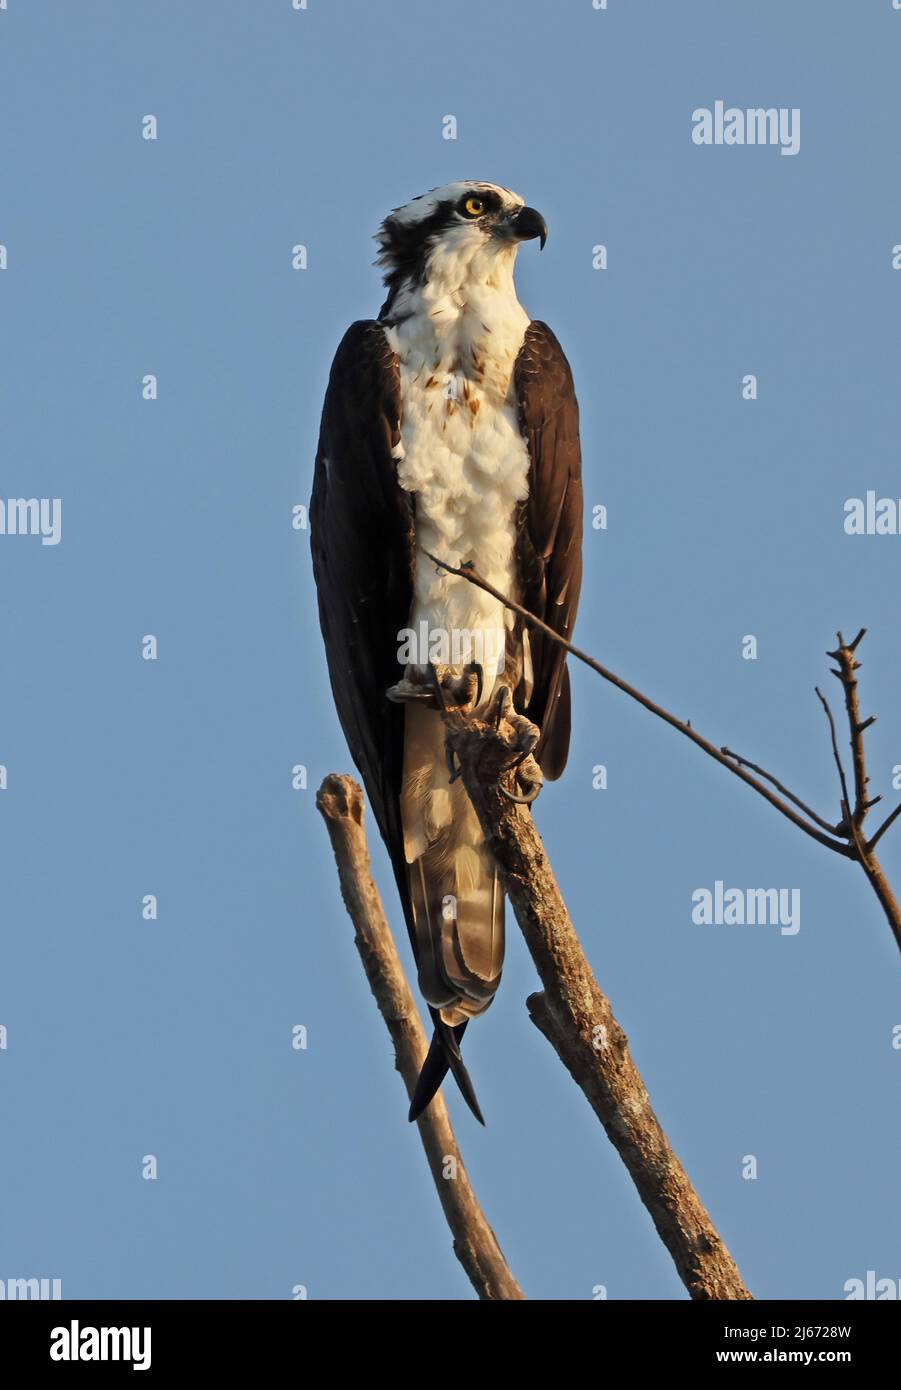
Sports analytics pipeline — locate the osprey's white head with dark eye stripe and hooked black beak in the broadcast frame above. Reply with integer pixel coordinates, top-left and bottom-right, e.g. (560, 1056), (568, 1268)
(375, 181), (548, 312)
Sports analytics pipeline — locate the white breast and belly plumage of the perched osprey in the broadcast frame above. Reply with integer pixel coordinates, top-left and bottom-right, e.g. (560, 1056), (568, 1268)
(388, 261), (528, 696)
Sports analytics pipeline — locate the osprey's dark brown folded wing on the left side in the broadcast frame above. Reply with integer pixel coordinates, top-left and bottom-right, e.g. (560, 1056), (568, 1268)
(310, 320), (413, 922)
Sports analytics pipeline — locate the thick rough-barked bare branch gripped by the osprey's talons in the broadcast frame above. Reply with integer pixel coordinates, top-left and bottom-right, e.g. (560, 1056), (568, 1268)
(444, 712), (751, 1300)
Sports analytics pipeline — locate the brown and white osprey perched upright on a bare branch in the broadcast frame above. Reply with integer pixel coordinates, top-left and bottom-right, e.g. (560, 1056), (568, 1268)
(310, 182), (583, 1123)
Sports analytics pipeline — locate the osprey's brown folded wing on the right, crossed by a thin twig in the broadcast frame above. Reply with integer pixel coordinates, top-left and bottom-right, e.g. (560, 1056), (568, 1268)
(513, 321), (583, 781)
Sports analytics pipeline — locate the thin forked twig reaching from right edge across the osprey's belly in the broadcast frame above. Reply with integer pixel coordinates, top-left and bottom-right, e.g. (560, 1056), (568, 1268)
(424, 550), (901, 949)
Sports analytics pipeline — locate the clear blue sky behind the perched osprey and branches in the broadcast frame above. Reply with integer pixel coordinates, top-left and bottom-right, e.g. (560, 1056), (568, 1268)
(0, 0), (901, 1300)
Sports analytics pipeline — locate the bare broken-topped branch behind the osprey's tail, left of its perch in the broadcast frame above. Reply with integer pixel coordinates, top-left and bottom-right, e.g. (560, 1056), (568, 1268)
(316, 773), (526, 1301)
